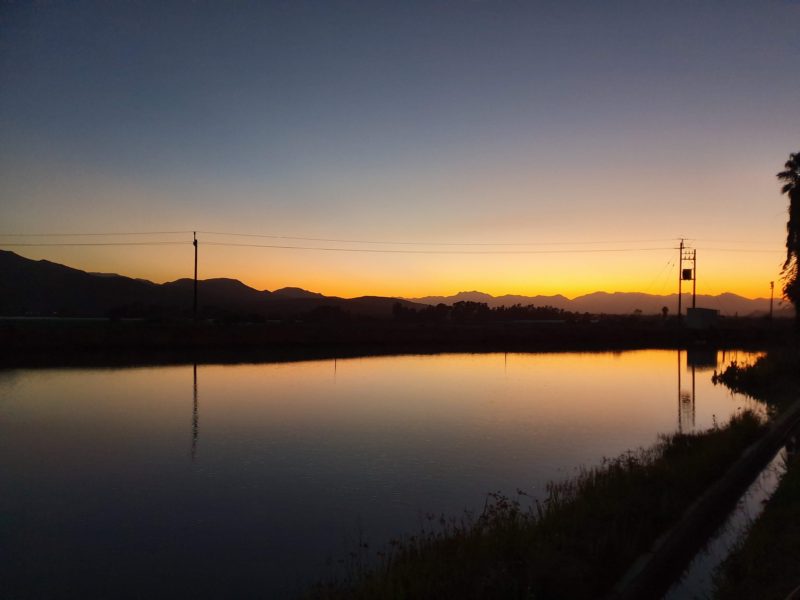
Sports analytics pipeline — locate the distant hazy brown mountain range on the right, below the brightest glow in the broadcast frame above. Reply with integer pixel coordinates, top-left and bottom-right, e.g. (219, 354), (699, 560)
(408, 291), (793, 317)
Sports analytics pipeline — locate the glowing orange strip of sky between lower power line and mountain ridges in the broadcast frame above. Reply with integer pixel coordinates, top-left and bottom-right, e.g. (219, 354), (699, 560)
(4, 245), (782, 299)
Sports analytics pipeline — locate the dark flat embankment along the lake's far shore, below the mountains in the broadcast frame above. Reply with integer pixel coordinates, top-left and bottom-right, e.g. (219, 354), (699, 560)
(0, 317), (791, 367)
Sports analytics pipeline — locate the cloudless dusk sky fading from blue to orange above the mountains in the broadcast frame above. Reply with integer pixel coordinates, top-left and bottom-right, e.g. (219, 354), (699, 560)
(0, 0), (800, 297)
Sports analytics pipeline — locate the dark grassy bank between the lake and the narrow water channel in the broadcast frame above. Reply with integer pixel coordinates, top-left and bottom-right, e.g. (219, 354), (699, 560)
(308, 413), (762, 599)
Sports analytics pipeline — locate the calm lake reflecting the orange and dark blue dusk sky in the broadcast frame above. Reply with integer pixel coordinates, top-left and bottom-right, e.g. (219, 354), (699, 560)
(0, 350), (762, 598)
